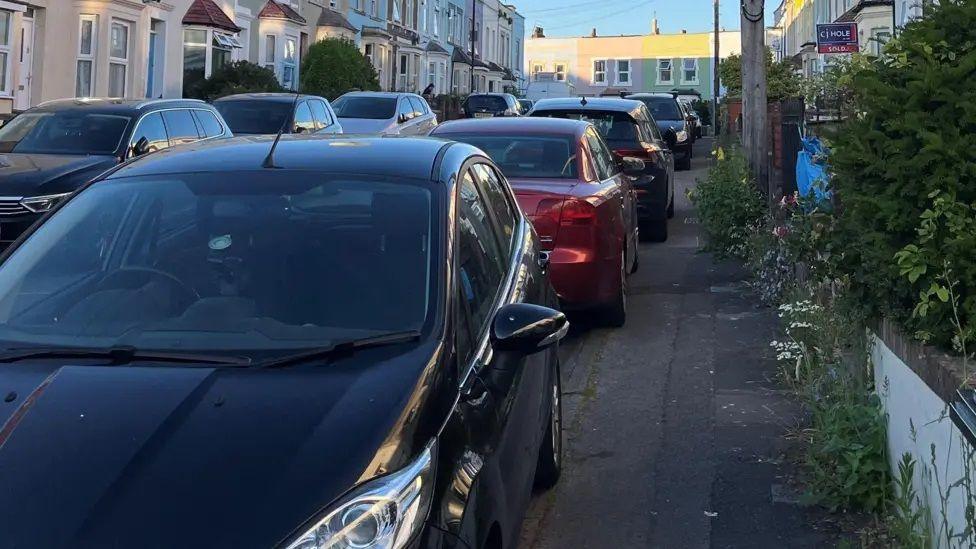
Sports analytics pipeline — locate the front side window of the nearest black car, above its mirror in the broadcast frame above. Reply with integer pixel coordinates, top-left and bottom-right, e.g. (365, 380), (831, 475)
(458, 171), (504, 334)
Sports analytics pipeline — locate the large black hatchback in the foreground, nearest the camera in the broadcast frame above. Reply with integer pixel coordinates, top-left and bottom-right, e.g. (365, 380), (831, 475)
(0, 136), (568, 549)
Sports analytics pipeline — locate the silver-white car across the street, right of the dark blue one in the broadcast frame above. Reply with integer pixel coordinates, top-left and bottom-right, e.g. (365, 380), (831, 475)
(332, 92), (437, 135)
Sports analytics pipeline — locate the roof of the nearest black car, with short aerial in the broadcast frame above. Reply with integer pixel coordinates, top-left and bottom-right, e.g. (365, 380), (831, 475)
(108, 135), (450, 180)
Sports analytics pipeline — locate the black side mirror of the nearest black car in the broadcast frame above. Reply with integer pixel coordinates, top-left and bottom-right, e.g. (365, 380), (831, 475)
(491, 303), (569, 355)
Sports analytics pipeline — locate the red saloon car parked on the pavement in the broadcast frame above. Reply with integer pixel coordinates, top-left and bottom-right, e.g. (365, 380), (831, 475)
(431, 118), (644, 326)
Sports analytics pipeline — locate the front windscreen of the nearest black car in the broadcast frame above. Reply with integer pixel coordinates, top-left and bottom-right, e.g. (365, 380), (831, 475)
(0, 170), (438, 356)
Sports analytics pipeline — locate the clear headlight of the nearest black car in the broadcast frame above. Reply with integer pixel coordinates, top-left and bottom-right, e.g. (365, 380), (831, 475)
(287, 441), (437, 549)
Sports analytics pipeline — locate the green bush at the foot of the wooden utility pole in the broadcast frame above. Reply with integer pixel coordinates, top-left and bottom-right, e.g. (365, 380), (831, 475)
(689, 144), (766, 259)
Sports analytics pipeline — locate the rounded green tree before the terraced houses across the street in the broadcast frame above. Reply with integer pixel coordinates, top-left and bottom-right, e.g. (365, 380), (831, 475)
(301, 38), (380, 99)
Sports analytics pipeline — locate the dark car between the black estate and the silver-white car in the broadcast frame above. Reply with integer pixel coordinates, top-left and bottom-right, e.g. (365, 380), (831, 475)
(213, 93), (342, 135)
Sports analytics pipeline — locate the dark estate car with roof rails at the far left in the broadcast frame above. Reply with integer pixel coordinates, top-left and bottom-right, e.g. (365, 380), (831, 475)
(0, 98), (231, 247)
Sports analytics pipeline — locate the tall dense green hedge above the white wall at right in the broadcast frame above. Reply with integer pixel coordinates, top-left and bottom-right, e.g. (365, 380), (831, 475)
(831, 0), (976, 345)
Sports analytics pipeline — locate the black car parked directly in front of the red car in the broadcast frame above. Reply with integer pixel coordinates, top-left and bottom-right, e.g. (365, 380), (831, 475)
(530, 98), (674, 242)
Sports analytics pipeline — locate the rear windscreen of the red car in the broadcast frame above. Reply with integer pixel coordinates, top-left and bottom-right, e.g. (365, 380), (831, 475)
(442, 134), (577, 179)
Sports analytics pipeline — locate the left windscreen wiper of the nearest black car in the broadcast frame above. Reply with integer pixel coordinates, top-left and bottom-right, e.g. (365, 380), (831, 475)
(0, 346), (251, 366)
